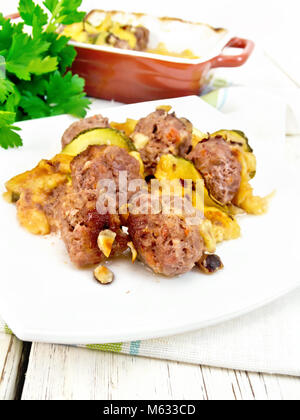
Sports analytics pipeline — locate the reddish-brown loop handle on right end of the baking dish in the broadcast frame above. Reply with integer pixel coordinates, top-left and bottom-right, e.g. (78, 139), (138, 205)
(211, 38), (255, 68)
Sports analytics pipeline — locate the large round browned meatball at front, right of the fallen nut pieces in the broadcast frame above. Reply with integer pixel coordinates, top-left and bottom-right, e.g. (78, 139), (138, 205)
(128, 195), (204, 276)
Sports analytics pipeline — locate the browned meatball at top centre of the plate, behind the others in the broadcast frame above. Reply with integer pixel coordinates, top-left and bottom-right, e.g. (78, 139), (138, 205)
(132, 110), (192, 175)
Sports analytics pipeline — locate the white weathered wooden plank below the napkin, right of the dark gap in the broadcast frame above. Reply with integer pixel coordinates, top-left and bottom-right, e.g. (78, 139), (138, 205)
(22, 344), (300, 400)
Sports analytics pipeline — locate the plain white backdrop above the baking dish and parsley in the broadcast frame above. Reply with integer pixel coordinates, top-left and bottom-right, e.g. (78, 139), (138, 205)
(0, 0), (300, 86)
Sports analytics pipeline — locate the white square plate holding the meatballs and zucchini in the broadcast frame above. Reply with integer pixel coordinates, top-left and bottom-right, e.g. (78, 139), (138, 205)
(0, 97), (300, 344)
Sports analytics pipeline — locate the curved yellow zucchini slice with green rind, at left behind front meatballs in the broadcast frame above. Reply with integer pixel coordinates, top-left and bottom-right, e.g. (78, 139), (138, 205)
(62, 128), (136, 156)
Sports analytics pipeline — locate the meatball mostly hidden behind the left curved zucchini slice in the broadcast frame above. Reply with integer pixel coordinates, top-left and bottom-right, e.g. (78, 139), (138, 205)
(61, 114), (109, 148)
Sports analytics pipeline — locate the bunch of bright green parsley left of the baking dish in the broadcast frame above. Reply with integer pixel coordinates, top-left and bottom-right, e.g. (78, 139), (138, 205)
(0, 0), (90, 149)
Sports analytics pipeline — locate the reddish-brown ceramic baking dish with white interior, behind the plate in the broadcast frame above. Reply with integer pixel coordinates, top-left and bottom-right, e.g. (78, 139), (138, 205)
(8, 10), (254, 103)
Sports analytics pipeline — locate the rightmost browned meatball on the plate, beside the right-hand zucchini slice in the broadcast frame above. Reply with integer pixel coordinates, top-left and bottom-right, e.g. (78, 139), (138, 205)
(187, 136), (242, 204)
